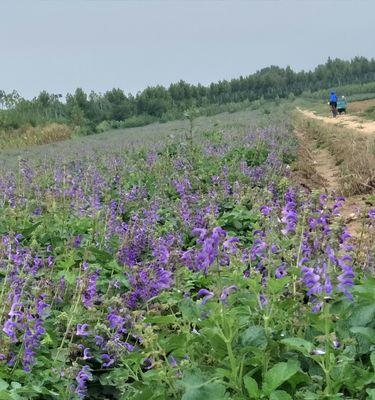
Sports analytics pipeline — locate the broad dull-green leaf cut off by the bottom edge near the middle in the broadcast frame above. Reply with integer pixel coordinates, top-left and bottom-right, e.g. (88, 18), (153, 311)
(181, 371), (228, 400)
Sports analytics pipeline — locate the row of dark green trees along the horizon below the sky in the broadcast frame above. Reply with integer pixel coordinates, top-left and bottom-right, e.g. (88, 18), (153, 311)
(0, 57), (375, 132)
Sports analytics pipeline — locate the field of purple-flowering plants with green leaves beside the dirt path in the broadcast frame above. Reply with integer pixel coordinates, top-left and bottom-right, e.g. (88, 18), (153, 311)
(0, 108), (375, 400)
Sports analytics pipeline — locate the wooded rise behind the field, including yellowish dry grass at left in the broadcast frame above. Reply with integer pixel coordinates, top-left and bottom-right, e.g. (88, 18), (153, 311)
(0, 57), (375, 148)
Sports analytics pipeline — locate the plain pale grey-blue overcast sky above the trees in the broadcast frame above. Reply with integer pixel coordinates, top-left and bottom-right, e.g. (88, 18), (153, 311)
(0, 0), (375, 98)
